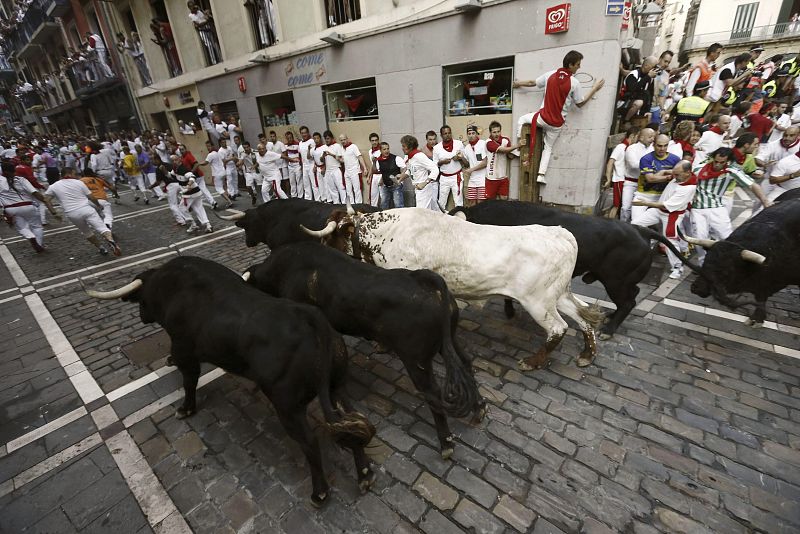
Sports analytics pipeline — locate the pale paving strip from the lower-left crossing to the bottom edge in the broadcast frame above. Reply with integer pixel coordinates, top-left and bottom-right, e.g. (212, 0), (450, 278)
(106, 430), (192, 534)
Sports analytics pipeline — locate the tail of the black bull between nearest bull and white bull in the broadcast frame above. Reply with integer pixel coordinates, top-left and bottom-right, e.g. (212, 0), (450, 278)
(439, 293), (484, 417)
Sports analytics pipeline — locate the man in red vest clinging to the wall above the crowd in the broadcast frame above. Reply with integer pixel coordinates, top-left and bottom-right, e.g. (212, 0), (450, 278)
(512, 50), (605, 184)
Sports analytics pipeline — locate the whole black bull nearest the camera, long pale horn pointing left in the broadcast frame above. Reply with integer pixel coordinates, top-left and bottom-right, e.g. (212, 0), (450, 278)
(83, 256), (375, 505)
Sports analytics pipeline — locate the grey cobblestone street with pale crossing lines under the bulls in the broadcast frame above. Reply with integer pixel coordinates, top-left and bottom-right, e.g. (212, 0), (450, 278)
(0, 192), (800, 534)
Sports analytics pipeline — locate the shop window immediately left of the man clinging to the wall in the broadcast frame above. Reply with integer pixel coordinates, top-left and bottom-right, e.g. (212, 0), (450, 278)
(445, 59), (514, 117)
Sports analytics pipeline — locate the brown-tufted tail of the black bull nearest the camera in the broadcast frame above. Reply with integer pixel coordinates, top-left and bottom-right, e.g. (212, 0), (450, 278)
(318, 334), (375, 449)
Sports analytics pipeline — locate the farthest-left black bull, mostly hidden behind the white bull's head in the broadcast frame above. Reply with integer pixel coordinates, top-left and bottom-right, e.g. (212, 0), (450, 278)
(218, 198), (379, 250)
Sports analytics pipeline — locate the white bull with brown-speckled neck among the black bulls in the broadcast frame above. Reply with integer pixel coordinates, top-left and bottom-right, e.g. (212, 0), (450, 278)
(303, 208), (602, 370)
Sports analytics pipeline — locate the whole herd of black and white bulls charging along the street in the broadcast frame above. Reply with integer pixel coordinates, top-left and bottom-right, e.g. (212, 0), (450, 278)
(88, 198), (800, 505)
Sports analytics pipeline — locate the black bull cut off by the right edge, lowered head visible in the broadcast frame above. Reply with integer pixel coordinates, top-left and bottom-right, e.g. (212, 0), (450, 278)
(687, 199), (800, 323)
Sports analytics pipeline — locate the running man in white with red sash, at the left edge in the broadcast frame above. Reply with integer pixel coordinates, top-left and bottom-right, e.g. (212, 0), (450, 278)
(0, 161), (59, 253)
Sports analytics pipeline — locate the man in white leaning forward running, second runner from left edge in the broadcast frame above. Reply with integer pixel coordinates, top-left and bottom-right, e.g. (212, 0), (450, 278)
(44, 168), (122, 256)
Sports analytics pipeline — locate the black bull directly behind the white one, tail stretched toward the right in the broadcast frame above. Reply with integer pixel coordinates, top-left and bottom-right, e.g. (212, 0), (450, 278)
(450, 200), (697, 338)
